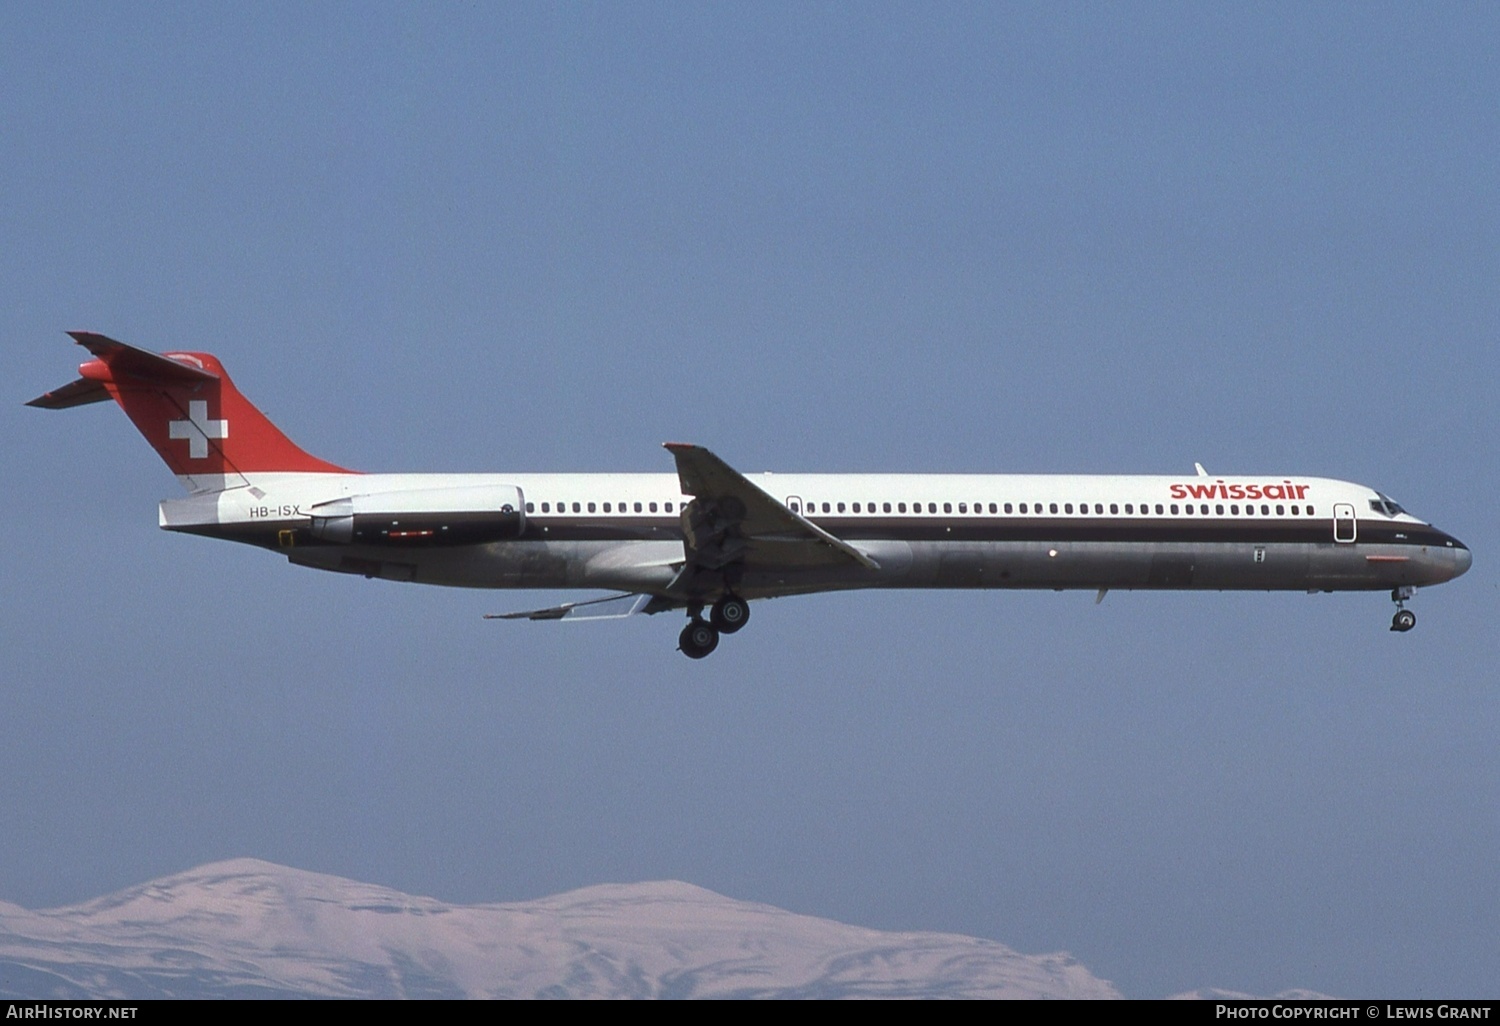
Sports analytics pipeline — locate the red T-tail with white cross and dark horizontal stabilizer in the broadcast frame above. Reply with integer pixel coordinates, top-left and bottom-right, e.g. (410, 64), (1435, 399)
(27, 332), (354, 494)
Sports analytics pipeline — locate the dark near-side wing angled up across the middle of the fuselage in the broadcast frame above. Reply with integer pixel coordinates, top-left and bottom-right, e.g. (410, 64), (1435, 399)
(665, 443), (881, 572)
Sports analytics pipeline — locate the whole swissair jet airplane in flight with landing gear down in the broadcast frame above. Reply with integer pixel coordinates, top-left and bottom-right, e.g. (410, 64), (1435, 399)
(27, 332), (1472, 659)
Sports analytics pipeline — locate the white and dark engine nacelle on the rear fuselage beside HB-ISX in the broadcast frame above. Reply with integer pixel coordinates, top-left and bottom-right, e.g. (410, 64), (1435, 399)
(308, 485), (527, 546)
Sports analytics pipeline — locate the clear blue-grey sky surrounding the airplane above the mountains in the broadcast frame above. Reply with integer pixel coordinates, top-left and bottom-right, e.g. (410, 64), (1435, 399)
(0, 5), (1500, 996)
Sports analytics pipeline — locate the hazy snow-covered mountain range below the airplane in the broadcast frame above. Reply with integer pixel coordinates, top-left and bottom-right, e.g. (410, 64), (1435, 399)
(0, 858), (1121, 999)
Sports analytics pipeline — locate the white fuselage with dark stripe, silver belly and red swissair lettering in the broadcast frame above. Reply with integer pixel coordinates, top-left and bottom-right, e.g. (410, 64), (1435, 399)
(161, 473), (1470, 599)
